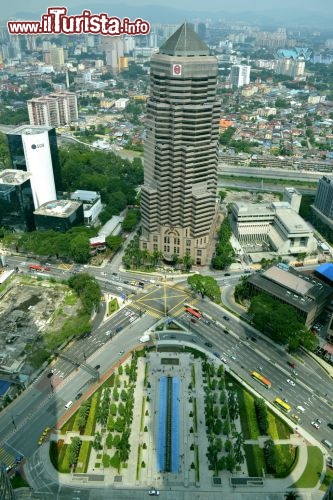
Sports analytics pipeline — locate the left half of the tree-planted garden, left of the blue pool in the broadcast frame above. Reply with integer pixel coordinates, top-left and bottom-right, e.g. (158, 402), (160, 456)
(50, 353), (138, 473)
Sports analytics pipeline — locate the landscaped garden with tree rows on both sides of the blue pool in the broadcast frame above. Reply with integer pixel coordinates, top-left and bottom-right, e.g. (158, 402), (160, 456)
(50, 346), (304, 482)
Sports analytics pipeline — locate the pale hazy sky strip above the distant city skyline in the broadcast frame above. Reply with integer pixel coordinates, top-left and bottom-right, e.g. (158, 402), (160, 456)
(1, 0), (333, 19)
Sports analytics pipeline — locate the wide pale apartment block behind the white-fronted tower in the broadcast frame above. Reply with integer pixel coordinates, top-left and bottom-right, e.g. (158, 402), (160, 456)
(27, 92), (79, 127)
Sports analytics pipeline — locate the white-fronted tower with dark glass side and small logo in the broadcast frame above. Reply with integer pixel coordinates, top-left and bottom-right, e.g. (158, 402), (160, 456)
(7, 125), (61, 209)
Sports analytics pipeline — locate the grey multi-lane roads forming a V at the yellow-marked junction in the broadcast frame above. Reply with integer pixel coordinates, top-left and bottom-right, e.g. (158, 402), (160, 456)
(0, 257), (333, 498)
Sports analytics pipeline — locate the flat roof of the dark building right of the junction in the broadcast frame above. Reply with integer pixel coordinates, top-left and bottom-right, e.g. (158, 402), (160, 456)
(249, 264), (333, 311)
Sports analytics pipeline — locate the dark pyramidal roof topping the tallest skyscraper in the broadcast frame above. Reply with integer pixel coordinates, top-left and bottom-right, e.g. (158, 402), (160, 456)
(160, 23), (209, 56)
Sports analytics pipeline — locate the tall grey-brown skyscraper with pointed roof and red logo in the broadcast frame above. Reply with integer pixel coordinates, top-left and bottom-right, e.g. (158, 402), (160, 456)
(140, 23), (220, 265)
